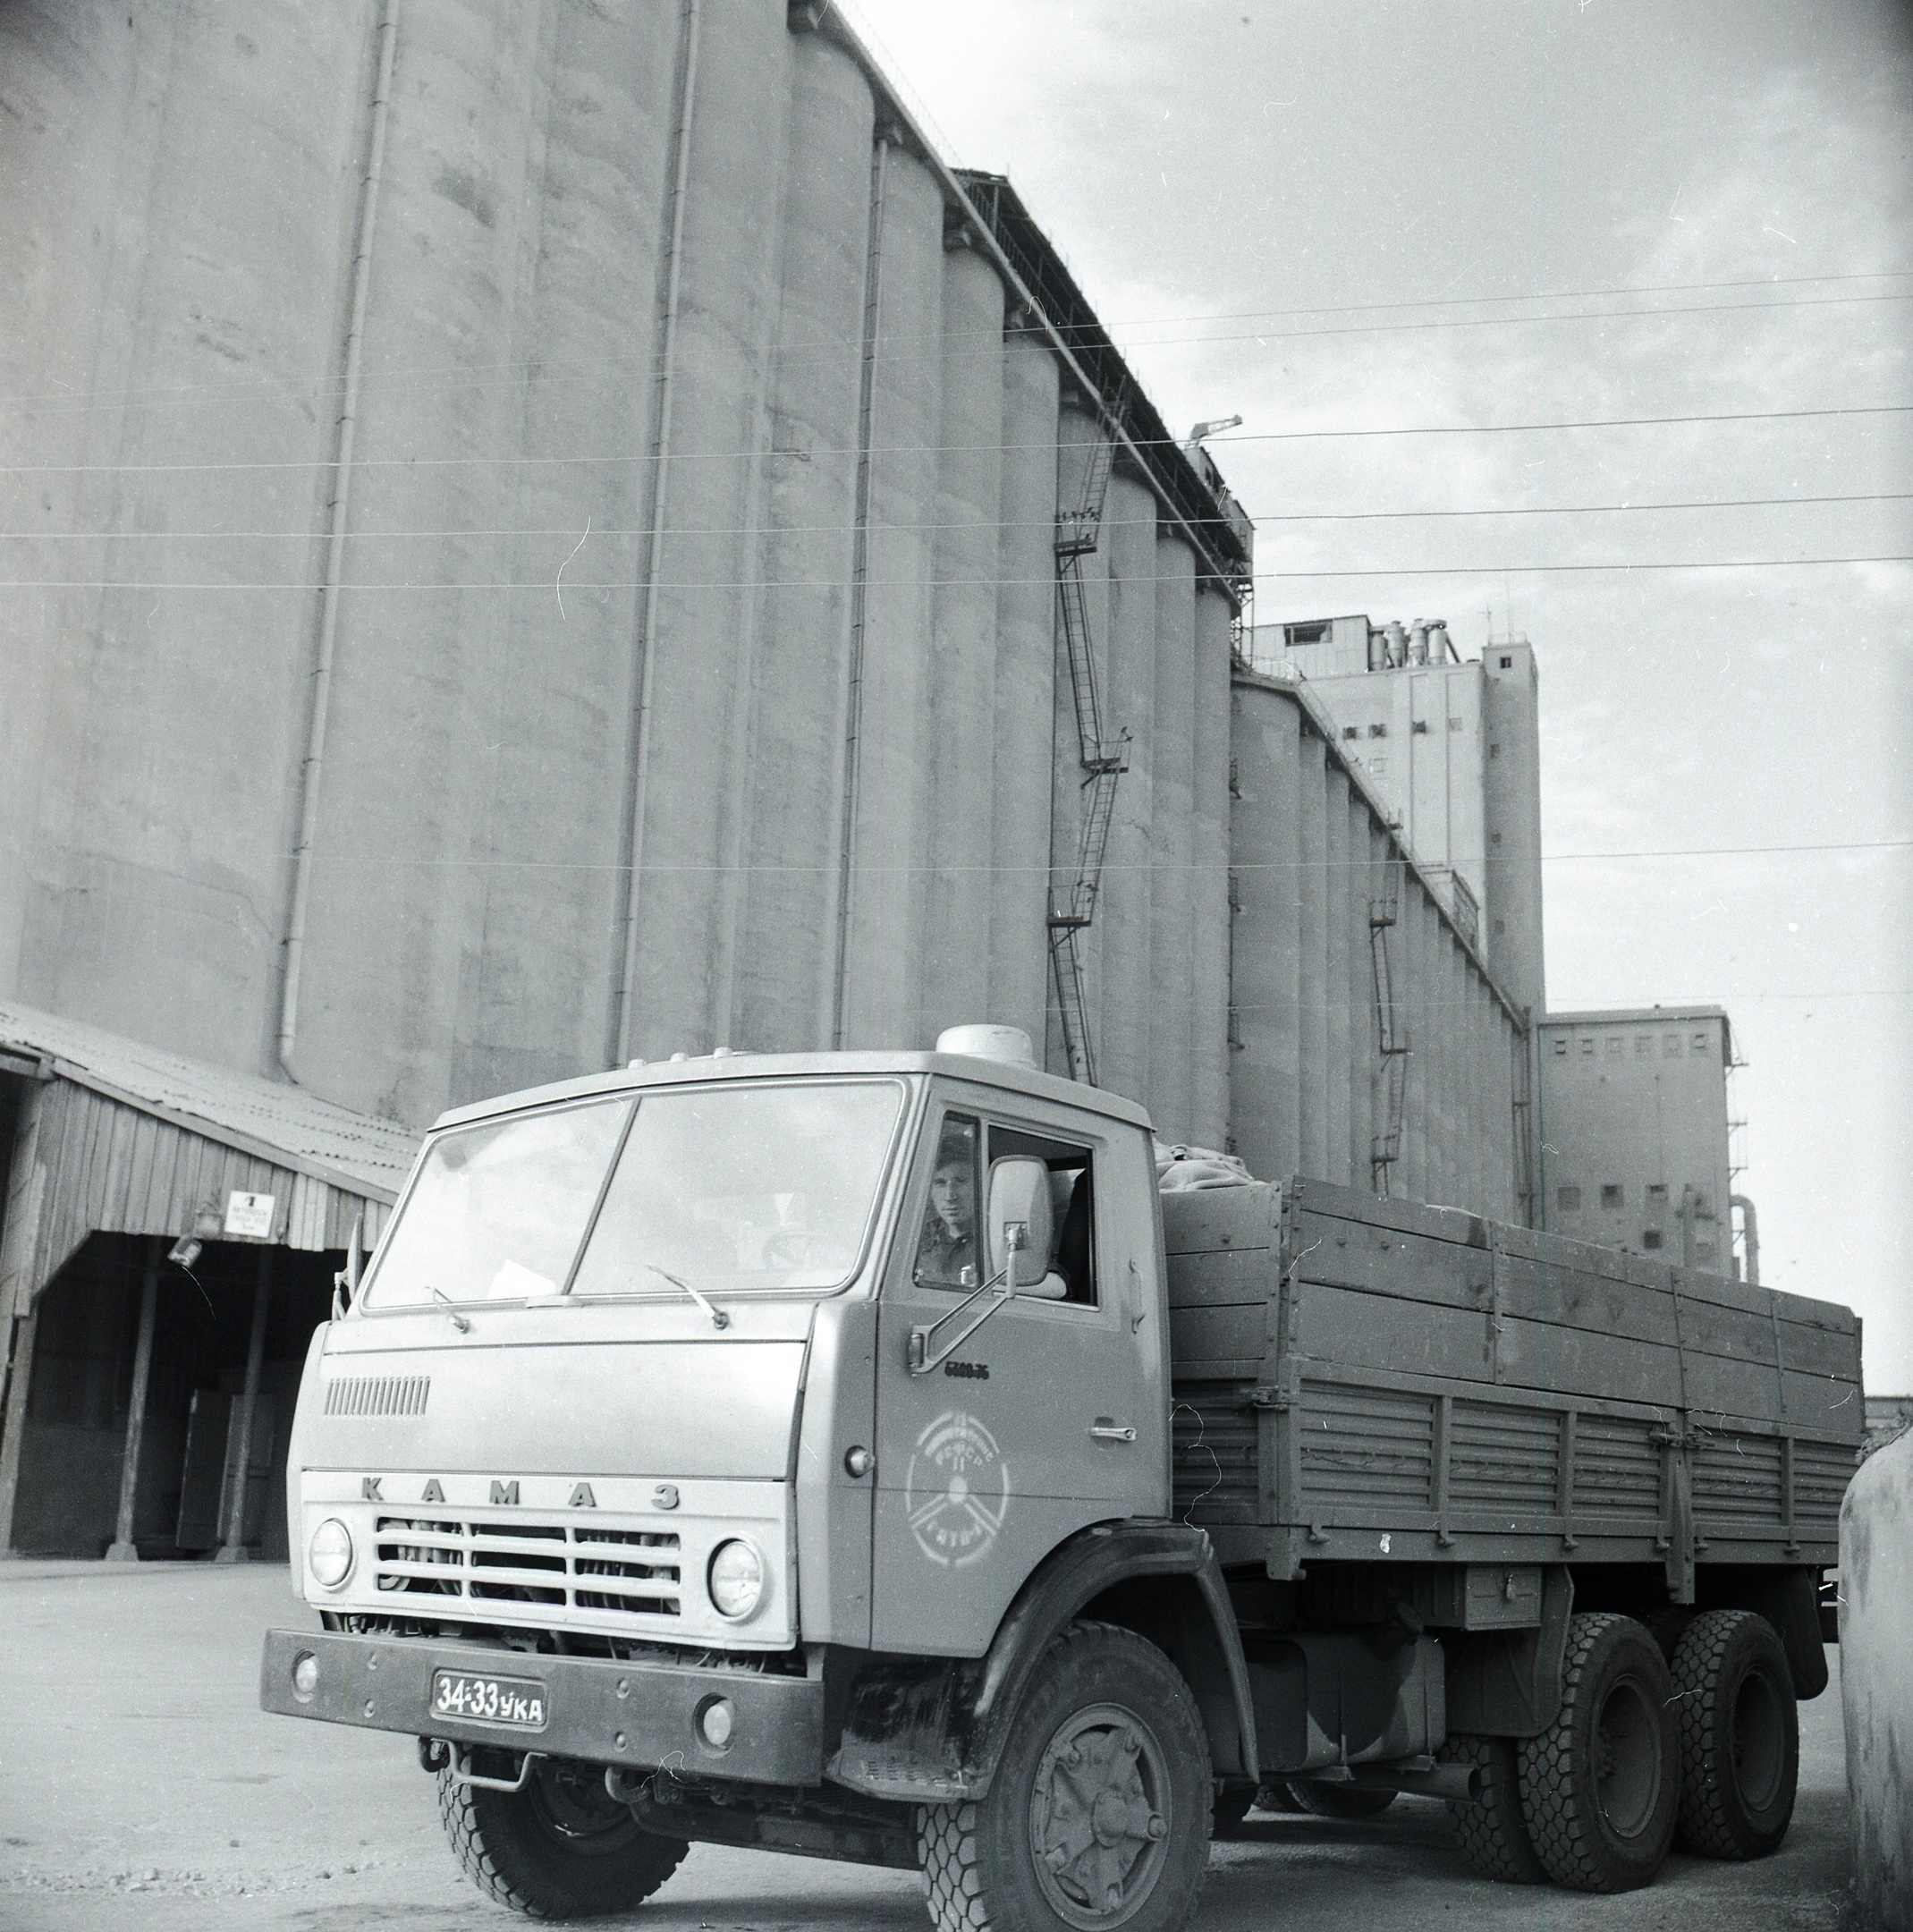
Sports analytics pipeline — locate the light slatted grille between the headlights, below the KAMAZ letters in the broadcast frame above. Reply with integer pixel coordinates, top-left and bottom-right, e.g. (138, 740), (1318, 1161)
(373, 1517), (681, 1617)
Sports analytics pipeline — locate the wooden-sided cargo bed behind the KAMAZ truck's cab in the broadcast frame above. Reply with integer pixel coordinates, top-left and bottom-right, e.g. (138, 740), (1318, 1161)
(1164, 1179), (1863, 1602)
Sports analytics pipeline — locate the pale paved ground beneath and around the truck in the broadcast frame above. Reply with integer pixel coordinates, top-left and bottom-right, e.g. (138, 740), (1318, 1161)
(0, 1563), (1848, 1932)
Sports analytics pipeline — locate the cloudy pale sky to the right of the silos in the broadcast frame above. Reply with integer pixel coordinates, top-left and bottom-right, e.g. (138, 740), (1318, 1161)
(844, 0), (1913, 1393)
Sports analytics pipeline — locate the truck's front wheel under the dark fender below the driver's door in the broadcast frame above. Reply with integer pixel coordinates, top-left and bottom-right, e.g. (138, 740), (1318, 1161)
(916, 1623), (1214, 1932)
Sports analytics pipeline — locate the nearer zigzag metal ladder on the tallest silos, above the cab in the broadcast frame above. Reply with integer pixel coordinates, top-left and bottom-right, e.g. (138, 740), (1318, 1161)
(1049, 409), (1129, 1086)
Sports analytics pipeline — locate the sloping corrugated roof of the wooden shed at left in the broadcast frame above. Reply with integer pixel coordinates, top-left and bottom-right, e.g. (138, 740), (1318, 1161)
(0, 1001), (419, 1204)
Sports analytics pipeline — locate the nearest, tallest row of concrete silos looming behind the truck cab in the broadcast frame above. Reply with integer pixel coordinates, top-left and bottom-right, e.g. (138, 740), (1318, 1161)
(0, 0), (1259, 1140)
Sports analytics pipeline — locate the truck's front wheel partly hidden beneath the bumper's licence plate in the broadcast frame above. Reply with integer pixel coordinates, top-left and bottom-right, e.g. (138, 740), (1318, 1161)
(438, 1758), (690, 1919)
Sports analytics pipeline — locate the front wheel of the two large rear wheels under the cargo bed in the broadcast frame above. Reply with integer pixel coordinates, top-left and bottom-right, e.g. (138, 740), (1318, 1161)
(1519, 1611), (1681, 1892)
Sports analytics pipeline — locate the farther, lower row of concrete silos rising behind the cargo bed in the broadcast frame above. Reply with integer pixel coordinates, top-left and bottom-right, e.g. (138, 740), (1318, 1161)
(1229, 673), (1523, 1219)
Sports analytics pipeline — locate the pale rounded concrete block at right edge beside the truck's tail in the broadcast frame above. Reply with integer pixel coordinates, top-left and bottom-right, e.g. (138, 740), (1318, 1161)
(1840, 1436), (1913, 1932)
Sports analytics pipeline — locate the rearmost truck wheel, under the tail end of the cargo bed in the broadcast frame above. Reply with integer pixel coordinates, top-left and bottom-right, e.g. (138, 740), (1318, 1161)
(1673, 1609), (1801, 1859)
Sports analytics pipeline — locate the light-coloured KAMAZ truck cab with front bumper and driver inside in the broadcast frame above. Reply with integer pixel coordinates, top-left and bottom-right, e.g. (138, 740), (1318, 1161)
(263, 1028), (1229, 1911)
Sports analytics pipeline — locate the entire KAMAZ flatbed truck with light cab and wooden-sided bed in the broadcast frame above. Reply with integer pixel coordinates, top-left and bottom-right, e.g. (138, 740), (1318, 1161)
(261, 1028), (1863, 1932)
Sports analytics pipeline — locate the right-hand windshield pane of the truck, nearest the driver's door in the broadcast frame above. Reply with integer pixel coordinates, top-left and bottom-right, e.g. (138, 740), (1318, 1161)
(574, 1080), (902, 1294)
